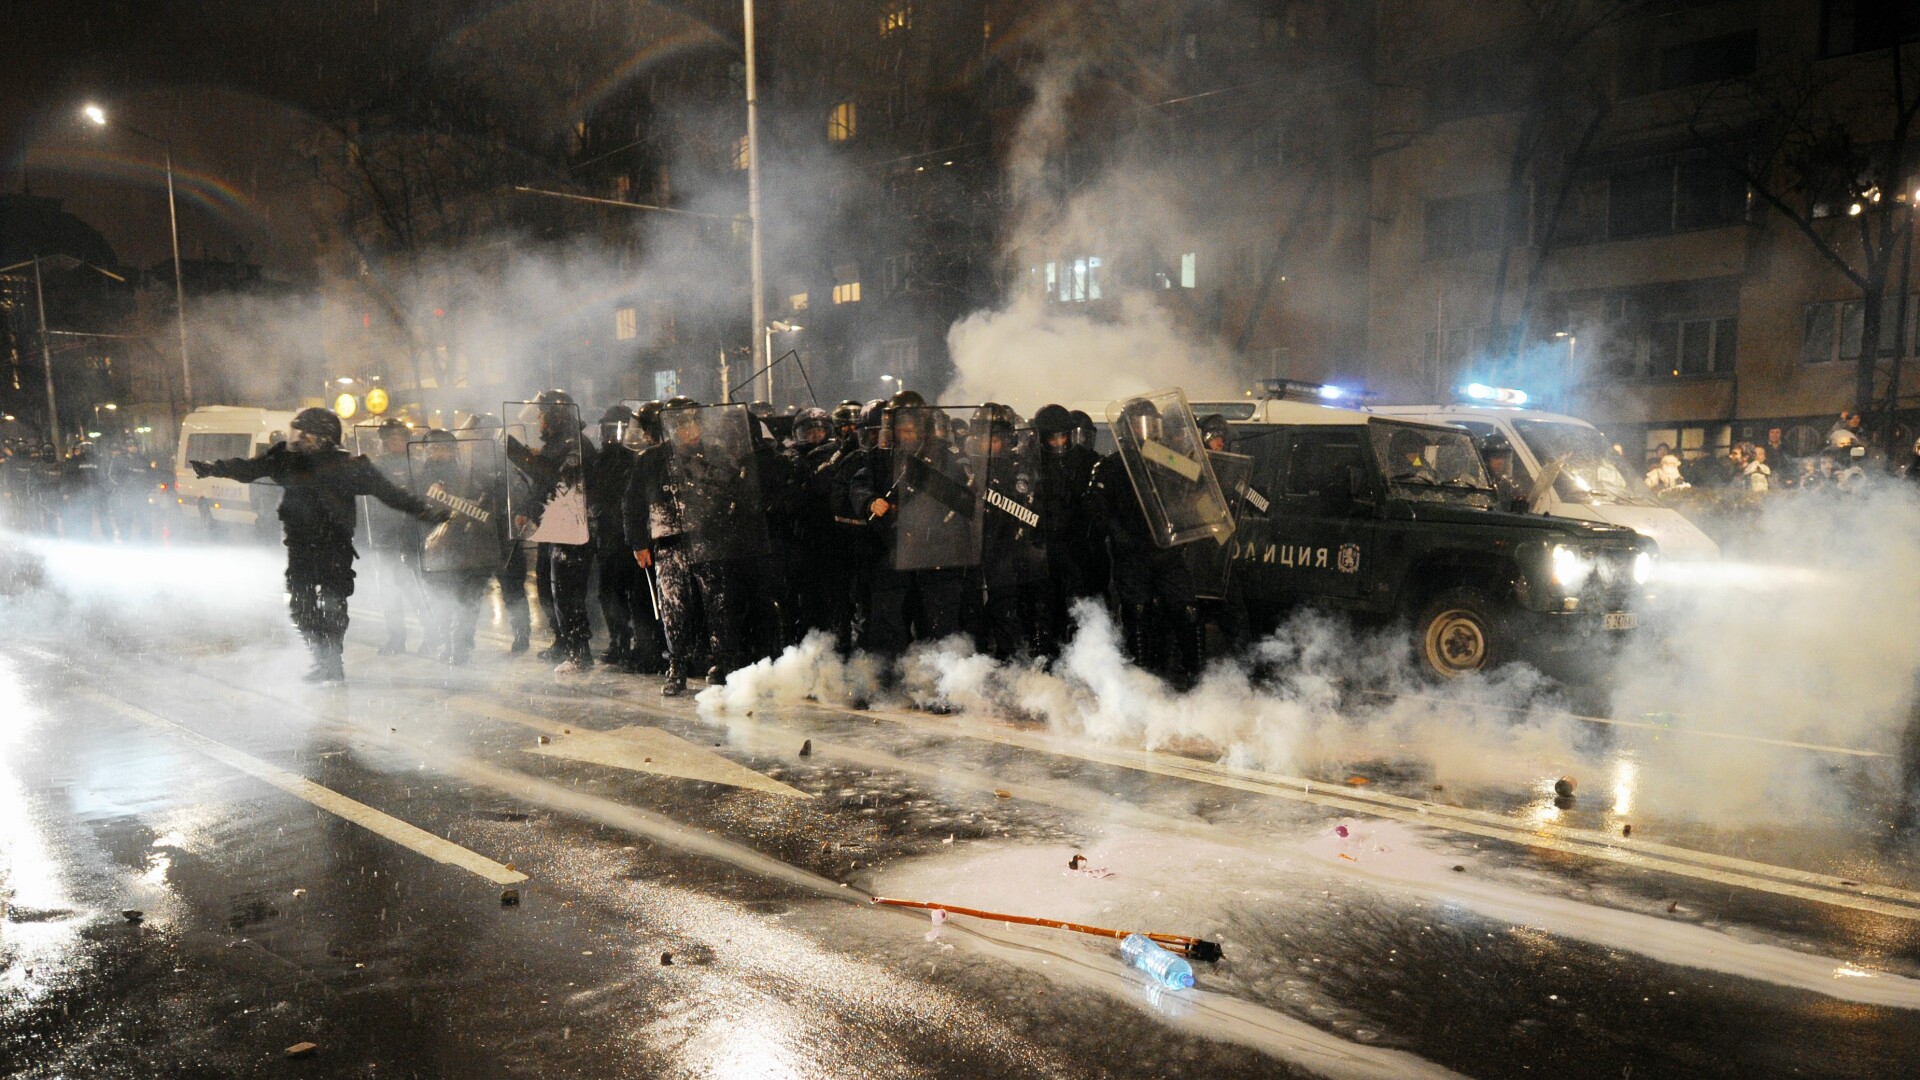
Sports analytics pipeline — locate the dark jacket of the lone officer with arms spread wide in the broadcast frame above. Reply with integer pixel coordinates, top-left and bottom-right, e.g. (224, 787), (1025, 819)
(207, 442), (447, 550)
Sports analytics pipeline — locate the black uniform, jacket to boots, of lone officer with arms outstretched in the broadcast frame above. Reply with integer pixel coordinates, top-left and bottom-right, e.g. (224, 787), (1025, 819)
(205, 442), (445, 678)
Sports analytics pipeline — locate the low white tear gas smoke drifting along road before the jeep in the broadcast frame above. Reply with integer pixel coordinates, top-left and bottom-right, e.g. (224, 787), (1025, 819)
(699, 486), (1920, 826)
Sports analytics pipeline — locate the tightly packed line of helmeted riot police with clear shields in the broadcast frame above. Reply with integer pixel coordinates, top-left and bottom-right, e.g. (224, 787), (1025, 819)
(243, 390), (1200, 696)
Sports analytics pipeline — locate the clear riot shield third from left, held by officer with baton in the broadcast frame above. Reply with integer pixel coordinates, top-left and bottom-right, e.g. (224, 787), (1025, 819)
(655, 404), (772, 563)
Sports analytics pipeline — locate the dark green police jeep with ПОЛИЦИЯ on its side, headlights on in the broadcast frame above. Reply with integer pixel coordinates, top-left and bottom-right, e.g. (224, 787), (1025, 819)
(1194, 400), (1655, 676)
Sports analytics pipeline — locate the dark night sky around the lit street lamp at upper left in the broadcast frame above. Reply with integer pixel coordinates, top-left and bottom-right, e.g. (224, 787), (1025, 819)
(0, 0), (737, 279)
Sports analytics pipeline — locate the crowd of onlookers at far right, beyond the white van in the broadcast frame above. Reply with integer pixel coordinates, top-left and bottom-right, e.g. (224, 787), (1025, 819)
(1645, 409), (1889, 494)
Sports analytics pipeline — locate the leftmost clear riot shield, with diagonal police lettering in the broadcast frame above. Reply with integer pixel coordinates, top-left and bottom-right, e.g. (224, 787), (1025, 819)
(407, 432), (511, 575)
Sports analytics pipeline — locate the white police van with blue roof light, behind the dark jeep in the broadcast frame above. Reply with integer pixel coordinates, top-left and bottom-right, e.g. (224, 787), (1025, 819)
(1367, 405), (1720, 561)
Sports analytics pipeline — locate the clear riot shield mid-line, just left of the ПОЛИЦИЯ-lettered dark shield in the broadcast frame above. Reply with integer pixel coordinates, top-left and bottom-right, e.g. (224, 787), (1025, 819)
(881, 405), (985, 571)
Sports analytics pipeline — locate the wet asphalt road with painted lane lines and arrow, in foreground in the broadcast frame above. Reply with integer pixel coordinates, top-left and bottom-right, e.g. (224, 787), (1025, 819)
(0, 534), (1920, 1078)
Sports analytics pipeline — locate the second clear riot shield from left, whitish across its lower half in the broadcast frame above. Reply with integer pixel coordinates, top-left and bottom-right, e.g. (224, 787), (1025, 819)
(501, 402), (589, 544)
